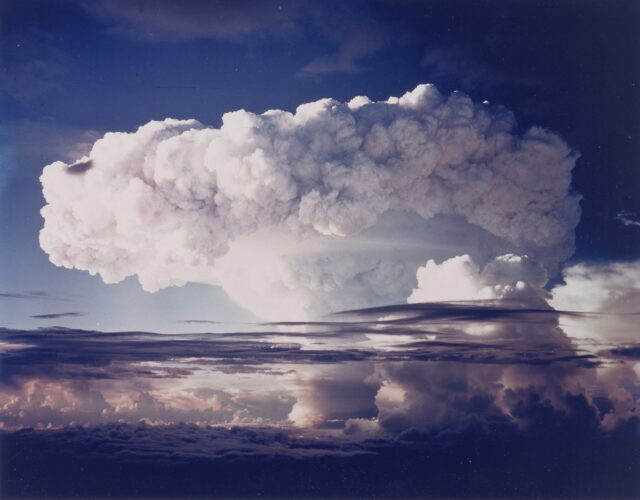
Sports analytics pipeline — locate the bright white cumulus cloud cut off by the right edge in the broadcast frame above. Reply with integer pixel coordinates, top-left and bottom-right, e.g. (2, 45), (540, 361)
(550, 261), (640, 341)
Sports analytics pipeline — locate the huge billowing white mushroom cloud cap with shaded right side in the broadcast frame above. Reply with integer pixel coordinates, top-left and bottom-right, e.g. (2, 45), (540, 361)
(40, 85), (579, 319)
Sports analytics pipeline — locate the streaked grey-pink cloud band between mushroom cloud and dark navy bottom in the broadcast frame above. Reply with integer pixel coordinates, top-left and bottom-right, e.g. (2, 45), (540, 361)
(0, 302), (640, 438)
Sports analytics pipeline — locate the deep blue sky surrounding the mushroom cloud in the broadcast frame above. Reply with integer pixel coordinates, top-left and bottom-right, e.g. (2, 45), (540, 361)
(0, 0), (640, 327)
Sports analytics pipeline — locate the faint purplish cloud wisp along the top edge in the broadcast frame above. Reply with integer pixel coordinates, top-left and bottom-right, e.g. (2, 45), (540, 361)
(78, 0), (389, 77)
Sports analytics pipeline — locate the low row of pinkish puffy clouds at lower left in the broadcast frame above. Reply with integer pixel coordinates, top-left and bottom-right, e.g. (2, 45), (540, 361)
(0, 379), (292, 429)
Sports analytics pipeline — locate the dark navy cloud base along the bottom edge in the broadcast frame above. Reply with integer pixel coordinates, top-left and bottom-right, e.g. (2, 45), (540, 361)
(1, 410), (640, 498)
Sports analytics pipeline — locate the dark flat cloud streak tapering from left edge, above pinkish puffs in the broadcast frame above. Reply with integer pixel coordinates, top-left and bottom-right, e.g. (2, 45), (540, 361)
(0, 328), (373, 383)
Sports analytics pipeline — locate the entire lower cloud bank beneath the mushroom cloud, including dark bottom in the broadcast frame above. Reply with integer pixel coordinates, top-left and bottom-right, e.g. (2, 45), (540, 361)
(0, 308), (640, 498)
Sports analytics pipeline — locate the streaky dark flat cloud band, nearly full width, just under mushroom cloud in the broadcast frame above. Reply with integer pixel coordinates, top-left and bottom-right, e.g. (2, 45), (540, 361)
(0, 296), (601, 390)
